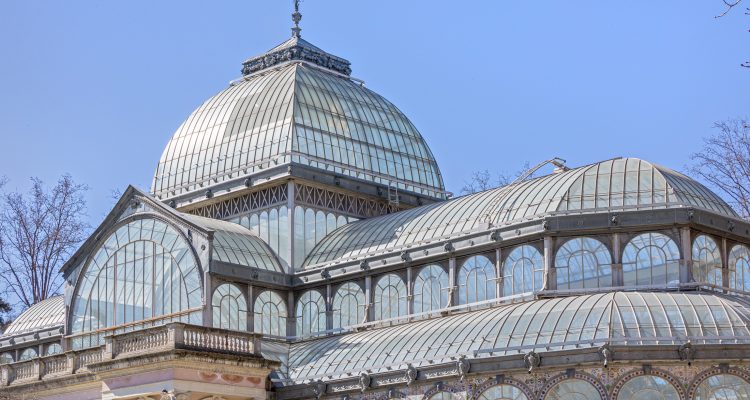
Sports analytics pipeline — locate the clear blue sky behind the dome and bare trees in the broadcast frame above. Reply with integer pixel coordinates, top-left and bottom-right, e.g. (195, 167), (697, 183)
(0, 0), (750, 224)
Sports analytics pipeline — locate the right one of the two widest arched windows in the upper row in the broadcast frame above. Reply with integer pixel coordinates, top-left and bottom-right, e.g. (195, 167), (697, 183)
(622, 233), (680, 286)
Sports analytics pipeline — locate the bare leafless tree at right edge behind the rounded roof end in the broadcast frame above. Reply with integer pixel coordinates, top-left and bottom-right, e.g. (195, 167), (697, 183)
(690, 119), (750, 220)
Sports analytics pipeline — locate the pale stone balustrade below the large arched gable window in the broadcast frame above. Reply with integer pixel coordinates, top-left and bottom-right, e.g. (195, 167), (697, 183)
(0, 322), (260, 386)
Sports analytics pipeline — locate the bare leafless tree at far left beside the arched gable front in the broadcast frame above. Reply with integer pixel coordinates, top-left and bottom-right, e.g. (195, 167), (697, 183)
(0, 175), (88, 307)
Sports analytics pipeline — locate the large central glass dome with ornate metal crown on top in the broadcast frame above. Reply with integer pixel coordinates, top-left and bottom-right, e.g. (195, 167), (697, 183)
(152, 38), (445, 199)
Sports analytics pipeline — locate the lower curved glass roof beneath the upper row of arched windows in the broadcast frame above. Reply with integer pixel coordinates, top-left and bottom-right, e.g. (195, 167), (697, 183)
(289, 292), (750, 382)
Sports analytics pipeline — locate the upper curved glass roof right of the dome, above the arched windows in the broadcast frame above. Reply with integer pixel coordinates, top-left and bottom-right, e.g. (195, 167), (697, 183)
(305, 158), (739, 266)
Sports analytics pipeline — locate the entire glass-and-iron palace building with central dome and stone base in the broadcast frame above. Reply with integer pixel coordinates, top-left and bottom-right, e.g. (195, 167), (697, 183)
(0, 14), (750, 400)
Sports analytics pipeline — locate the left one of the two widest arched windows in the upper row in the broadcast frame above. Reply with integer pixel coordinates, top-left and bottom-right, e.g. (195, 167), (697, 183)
(555, 237), (612, 289)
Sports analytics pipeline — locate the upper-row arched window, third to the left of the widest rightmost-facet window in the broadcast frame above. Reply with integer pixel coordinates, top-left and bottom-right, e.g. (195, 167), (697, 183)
(458, 256), (496, 304)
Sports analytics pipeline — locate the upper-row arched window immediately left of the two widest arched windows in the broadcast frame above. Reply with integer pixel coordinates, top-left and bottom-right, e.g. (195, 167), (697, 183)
(503, 245), (544, 296)
